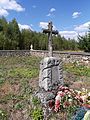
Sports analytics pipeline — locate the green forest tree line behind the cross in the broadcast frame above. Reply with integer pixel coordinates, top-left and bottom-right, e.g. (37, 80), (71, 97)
(0, 17), (90, 52)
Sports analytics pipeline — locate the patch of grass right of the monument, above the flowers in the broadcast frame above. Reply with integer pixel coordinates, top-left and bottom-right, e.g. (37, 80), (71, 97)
(63, 63), (90, 90)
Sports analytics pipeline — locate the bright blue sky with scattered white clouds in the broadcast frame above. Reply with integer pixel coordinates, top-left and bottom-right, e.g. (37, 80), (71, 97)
(0, 0), (90, 39)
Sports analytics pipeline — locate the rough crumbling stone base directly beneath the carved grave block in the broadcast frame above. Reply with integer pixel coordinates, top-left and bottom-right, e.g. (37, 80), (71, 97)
(37, 89), (56, 120)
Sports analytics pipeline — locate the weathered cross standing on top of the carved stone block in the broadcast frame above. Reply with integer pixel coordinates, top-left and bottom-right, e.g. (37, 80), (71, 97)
(43, 22), (58, 57)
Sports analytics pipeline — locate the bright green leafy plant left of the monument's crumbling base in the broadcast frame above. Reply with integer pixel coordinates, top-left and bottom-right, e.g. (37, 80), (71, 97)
(32, 108), (43, 120)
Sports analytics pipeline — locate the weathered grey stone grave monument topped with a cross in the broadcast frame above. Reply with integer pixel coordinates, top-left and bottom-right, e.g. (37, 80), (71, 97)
(38, 22), (63, 119)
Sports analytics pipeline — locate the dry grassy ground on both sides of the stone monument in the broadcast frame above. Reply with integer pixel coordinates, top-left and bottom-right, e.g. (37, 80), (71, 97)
(0, 56), (90, 120)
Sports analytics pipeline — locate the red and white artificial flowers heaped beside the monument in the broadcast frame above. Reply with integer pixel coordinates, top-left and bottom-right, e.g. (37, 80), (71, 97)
(54, 86), (90, 112)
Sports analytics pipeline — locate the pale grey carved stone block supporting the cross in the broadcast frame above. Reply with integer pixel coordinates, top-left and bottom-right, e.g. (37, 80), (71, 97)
(39, 57), (63, 91)
